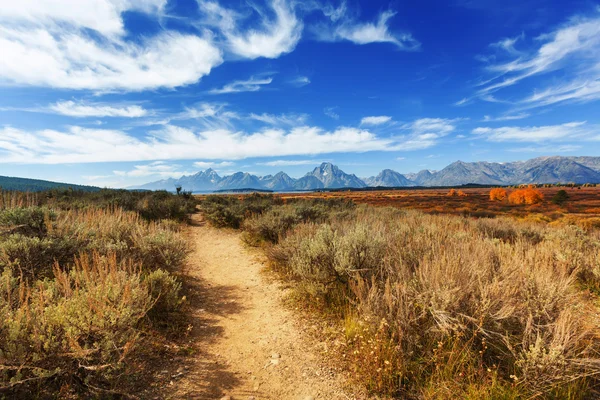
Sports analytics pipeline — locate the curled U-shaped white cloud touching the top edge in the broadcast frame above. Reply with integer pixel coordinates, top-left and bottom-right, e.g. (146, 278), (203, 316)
(199, 0), (304, 59)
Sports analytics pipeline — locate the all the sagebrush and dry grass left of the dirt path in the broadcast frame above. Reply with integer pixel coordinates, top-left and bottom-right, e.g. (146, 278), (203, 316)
(0, 191), (195, 398)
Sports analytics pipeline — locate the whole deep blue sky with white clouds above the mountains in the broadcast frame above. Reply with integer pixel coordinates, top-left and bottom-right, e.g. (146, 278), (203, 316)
(0, 0), (600, 187)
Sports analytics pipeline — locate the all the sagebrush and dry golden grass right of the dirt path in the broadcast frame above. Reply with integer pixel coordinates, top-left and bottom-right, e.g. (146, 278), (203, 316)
(202, 190), (600, 399)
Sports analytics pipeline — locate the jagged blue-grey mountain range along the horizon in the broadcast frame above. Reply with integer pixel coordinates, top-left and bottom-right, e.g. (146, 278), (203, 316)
(135, 156), (600, 192)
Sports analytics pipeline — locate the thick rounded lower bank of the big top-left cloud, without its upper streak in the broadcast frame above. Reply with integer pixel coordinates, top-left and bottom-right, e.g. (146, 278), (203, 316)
(0, 26), (223, 91)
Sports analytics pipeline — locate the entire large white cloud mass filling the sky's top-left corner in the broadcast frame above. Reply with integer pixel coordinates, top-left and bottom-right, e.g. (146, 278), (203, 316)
(0, 0), (223, 91)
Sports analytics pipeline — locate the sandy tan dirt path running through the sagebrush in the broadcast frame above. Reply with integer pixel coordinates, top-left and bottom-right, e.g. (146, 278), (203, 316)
(169, 215), (365, 400)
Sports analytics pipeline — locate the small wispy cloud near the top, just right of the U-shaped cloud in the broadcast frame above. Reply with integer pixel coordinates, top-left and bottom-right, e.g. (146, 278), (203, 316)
(316, 11), (420, 50)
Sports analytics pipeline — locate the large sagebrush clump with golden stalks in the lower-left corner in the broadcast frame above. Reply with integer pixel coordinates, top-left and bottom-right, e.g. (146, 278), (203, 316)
(0, 255), (151, 396)
